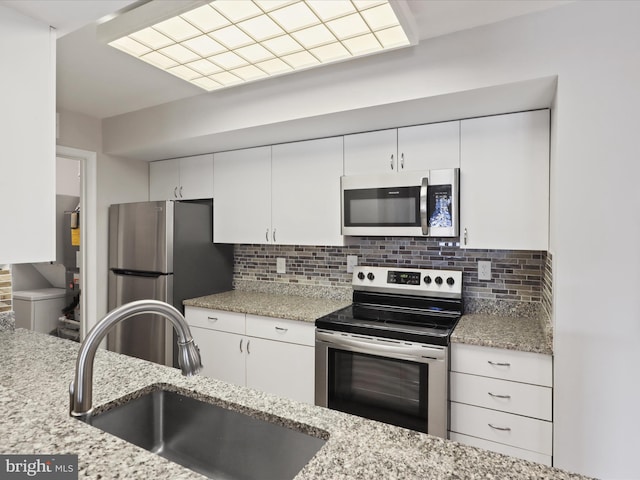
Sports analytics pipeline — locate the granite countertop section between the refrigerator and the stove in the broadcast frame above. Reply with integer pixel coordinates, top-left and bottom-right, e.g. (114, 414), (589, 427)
(183, 290), (351, 322)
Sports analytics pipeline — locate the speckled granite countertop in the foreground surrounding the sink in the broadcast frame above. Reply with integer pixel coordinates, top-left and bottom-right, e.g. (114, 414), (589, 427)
(0, 329), (586, 480)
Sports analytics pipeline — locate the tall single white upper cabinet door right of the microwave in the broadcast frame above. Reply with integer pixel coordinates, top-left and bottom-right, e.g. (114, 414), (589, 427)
(460, 110), (549, 250)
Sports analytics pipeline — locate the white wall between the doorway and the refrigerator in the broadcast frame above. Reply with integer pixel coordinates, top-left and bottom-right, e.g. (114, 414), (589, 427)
(58, 110), (149, 328)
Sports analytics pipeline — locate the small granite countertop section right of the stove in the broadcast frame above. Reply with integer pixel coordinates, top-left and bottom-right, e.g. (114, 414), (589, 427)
(451, 313), (553, 355)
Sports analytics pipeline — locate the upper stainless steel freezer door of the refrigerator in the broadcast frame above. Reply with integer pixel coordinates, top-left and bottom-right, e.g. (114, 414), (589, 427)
(109, 202), (174, 273)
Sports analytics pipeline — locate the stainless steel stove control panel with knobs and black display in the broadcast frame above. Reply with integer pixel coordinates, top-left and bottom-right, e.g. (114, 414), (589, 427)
(352, 265), (462, 297)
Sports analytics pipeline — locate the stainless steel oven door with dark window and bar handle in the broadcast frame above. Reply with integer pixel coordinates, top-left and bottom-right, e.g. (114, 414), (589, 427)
(315, 329), (449, 438)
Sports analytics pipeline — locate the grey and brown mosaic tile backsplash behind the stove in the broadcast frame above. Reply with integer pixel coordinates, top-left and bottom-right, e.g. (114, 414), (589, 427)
(234, 237), (552, 314)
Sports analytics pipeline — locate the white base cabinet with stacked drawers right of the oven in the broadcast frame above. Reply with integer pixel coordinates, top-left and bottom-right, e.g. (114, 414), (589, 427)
(449, 344), (553, 465)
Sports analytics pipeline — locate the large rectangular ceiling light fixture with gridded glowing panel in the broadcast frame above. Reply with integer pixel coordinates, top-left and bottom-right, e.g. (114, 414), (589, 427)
(98, 0), (417, 91)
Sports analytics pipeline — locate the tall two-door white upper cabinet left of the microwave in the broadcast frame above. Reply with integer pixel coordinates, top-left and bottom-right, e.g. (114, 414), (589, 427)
(213, 137), (343, 245)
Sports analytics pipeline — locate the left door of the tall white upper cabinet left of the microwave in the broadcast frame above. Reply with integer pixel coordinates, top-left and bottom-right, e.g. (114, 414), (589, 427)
(213, 147), (273, 244)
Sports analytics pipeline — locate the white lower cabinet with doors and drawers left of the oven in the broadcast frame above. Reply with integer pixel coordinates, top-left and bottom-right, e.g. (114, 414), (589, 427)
(185, 307), (315, 404)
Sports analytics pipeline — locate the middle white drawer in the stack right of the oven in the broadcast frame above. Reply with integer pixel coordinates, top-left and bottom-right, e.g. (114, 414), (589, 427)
(449, 372), (552, 421)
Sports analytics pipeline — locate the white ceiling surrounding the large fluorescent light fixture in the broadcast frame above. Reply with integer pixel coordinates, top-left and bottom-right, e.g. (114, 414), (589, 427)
(0, 0), (573, 118)
